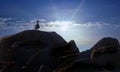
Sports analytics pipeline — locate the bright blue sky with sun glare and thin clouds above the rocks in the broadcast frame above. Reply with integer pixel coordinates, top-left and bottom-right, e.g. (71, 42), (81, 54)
(0, 0), (120, 50)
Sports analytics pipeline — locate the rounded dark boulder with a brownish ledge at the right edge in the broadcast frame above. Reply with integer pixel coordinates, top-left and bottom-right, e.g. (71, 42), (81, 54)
(90, 37), (120, 70)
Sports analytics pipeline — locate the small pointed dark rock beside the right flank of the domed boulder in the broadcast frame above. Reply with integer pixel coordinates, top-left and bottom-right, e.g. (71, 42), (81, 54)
(52, 41), (79, 59)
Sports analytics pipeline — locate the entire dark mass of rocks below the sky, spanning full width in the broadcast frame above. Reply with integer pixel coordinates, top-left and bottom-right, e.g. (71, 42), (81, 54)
(0, 30), (120, 72)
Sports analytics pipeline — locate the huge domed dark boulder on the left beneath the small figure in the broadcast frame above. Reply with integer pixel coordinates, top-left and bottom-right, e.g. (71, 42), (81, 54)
(0, 30), (66, 72)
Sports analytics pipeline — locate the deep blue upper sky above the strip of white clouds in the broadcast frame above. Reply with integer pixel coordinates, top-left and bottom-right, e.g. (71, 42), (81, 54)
(0, 0), (120, 23)
